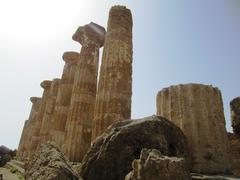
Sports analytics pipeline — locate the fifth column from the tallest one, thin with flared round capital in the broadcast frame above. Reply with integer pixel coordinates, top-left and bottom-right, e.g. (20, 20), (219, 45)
(29, 80), (52, 155)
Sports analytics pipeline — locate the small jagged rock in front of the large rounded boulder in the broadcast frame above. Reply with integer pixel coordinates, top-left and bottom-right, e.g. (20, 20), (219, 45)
(125, 149), (191, 180)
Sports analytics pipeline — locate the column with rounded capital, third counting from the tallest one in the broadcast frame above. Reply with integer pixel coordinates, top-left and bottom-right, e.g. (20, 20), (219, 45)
(50, 52), (79, 147)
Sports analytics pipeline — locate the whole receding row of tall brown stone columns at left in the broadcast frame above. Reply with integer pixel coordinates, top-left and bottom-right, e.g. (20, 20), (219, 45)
(17, 6), (132, 161)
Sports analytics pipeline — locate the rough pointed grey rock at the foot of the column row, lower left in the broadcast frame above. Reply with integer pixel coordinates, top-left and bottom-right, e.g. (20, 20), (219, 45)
(26, 143), (78, 180)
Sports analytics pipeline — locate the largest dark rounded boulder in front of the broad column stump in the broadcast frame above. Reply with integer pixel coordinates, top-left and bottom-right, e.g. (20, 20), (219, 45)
(80, 116), (188, 180)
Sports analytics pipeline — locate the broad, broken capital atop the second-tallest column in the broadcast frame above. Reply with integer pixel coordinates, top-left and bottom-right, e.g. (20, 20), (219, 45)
(72, 22), (106, 47)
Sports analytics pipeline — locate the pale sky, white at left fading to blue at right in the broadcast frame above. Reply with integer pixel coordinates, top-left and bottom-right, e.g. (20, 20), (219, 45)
(0, 0), (240, 148)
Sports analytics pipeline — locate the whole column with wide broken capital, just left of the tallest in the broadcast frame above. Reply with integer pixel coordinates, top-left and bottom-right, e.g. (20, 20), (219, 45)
(64, 23), (105, 161)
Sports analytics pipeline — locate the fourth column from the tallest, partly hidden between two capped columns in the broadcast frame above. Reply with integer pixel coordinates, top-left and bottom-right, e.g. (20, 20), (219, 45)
(40, 79), (60, 144)
